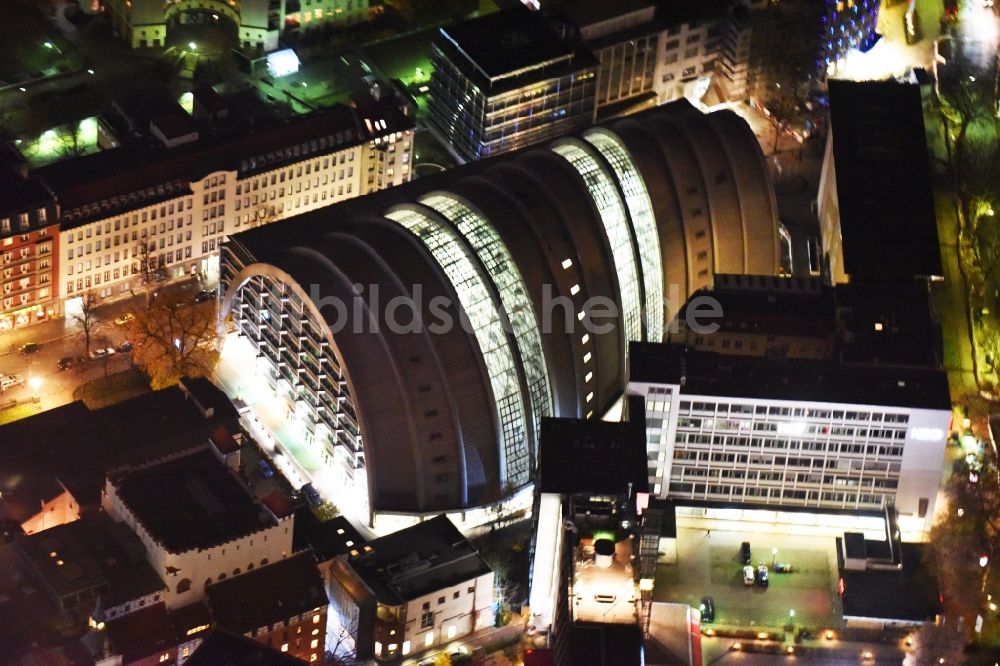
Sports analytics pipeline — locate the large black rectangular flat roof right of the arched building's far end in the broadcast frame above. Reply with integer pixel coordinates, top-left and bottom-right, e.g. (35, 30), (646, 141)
(829, 80), (942, 280)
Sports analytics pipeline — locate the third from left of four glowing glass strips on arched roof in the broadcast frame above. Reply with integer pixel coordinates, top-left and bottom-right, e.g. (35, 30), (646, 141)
(552, 143), (642, 342)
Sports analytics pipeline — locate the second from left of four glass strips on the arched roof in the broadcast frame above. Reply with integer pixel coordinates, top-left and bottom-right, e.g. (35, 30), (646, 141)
(420, 194), (552, 437)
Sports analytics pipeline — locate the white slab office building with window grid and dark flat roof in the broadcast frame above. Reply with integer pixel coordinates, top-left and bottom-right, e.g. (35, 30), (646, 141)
(629, 345), (951, 531)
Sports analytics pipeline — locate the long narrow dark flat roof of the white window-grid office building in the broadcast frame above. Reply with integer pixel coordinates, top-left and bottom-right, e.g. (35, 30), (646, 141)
(629, 342), (951, 409)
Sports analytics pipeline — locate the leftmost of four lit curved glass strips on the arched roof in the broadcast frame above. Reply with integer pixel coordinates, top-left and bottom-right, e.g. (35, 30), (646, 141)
(385, 208), (532, 486)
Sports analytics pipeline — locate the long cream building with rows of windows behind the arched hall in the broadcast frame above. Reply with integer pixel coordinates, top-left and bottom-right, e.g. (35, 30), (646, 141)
(52, 104), (413, 311)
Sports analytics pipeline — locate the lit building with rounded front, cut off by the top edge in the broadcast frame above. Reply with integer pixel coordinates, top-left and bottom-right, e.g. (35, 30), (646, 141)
(104, 0), (368, 51)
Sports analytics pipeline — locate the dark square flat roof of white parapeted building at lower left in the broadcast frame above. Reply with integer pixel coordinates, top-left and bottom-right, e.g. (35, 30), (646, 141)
(109, 449), (275, 553)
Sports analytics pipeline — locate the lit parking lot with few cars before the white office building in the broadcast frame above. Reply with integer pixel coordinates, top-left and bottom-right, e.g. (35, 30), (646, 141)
(653, 528), (841, 630)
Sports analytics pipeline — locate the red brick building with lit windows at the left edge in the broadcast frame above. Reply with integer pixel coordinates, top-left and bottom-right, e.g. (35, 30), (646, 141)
(0, 149), (59, 332)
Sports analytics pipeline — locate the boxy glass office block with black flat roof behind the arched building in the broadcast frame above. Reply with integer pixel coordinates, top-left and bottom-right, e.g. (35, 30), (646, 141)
(428, 8), (599, 160)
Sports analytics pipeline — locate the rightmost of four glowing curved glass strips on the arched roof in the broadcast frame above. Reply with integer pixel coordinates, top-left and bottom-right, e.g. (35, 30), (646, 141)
(583, 132), (664, 342)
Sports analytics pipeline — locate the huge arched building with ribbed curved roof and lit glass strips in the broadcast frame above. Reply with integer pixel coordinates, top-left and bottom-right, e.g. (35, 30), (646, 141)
(220, 101), (778, 521)
